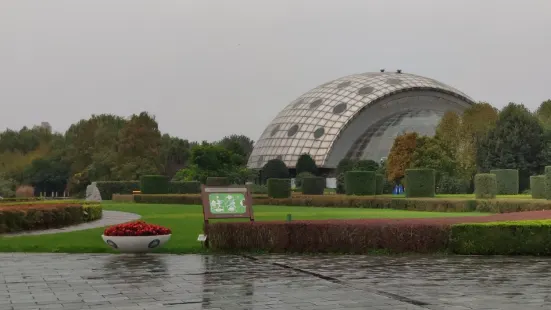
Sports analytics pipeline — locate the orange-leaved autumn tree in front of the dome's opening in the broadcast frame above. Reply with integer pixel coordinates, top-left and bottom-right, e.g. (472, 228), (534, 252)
(387, 132), (418, 182)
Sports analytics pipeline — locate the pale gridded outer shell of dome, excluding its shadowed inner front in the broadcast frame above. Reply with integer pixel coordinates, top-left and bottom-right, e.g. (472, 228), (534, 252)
(248, 72), (474, 168)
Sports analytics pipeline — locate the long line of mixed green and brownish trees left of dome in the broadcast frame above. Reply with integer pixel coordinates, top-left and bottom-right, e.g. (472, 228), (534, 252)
(0, 112), (254, 197)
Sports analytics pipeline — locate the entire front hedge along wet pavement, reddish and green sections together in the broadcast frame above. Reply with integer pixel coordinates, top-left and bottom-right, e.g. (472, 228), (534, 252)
(206, 220), (551, 255)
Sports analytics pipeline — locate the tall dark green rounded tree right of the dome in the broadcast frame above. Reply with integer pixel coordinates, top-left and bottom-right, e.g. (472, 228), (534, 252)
(477, 103), (544, 191)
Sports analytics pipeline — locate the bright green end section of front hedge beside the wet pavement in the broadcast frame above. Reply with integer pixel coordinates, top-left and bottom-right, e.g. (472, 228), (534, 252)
(450, 220), (551, 255)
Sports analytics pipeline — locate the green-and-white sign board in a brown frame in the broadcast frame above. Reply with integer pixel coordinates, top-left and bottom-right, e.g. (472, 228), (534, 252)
(201, 185), (254, 223)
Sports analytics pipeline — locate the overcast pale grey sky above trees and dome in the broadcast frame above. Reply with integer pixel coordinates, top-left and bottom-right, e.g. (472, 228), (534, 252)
(0, 0), (551, 140)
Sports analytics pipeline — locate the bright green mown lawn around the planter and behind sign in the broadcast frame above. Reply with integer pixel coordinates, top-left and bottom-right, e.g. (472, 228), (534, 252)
(0, 202), (485, 253)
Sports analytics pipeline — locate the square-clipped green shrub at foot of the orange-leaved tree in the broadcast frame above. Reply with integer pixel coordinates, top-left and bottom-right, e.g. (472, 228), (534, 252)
(404, 168), (436, 197)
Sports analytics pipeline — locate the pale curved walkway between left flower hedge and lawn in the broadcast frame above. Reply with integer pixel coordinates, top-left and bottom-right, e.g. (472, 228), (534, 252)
(0, 210), (141, 237)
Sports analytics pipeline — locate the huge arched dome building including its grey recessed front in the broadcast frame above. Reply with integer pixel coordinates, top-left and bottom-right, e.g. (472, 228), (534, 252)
(248, 71), (473, 169)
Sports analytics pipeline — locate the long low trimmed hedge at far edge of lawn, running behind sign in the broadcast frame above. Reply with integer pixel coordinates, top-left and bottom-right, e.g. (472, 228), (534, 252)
(134, 194), (551, 213)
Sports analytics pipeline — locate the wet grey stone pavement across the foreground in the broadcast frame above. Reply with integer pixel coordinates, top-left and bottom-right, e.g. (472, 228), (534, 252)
(0, 253), (551, 310)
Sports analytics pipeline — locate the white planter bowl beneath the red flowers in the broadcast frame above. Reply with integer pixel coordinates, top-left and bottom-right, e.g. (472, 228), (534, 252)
(101, 235), (171, 253)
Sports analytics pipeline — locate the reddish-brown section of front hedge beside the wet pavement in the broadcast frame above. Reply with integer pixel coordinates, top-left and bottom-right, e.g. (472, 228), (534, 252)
(208, 221), (449, 254)
